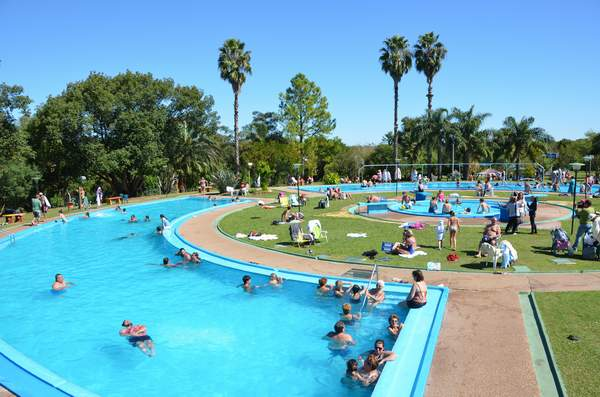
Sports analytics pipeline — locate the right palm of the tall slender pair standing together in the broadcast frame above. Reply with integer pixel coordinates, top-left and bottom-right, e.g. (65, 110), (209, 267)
(415, 32), (448, 177)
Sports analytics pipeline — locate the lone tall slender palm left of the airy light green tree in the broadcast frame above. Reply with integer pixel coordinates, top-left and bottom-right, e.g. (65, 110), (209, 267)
(219, 39), (252, 174)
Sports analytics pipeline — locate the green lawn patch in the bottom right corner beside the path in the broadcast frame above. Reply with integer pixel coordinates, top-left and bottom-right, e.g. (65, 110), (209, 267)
(535, 291), (600, 397)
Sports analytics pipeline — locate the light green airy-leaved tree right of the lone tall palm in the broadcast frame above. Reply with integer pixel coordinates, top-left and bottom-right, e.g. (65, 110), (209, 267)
(279, 73), (335, 175)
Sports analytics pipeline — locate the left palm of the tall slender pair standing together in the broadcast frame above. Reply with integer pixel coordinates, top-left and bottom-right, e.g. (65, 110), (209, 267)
(379, 35), (412, 161)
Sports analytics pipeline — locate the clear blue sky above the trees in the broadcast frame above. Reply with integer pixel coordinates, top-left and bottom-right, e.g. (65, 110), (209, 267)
(0, 0), (600, 144)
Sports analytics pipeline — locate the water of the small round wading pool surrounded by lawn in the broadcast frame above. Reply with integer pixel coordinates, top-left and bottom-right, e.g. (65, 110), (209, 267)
(388, 199), (500, 218)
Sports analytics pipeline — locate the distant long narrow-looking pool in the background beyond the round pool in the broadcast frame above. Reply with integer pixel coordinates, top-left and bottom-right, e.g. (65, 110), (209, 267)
(298, 182), (600, 193)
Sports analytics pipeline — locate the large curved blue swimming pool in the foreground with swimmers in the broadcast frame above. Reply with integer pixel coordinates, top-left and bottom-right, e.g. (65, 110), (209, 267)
(0, 198), (447, 396)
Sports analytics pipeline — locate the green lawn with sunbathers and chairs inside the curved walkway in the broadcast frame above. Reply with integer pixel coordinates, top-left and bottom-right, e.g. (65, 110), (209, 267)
(219, 192), (600, 271)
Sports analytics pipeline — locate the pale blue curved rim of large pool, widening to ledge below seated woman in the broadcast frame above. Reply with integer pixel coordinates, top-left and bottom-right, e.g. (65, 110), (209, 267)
(163, 200), (450, 397)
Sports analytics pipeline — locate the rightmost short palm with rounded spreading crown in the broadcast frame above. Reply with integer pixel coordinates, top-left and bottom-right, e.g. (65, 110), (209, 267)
(501, 116), (552, 179)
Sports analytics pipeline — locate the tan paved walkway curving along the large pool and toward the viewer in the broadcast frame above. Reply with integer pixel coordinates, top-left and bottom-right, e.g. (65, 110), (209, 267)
(180, 204), (600, 397)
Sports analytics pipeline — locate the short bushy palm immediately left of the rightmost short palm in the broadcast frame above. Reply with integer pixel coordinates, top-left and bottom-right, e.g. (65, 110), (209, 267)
(450, 106), (491, 179)
